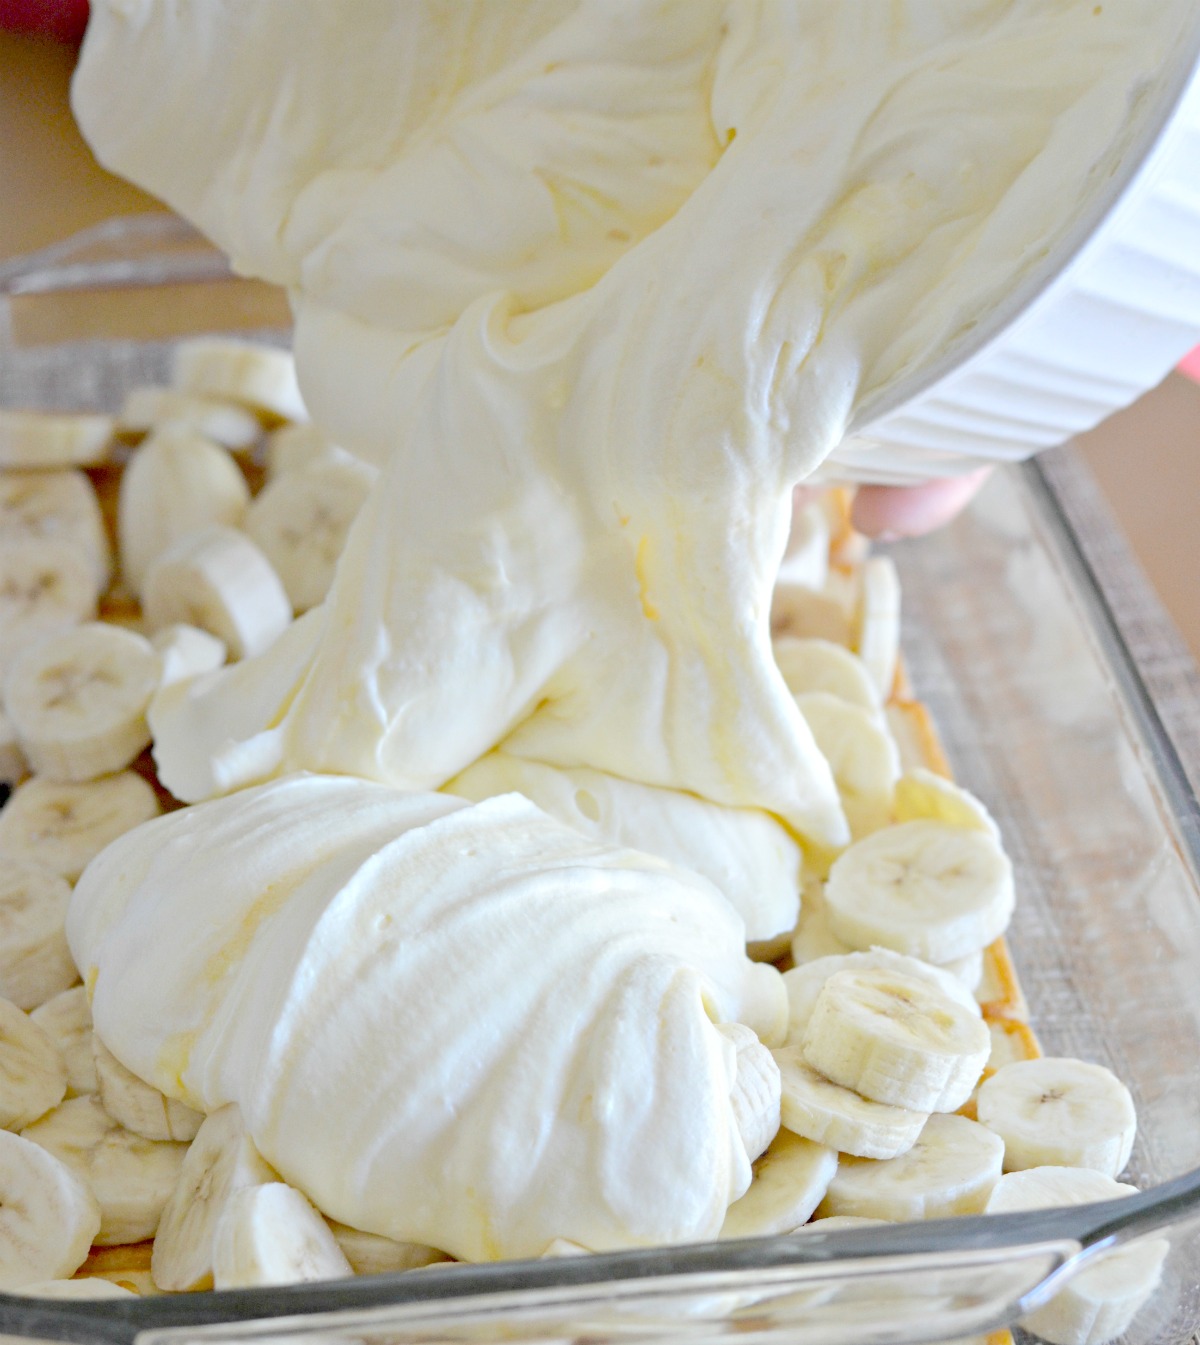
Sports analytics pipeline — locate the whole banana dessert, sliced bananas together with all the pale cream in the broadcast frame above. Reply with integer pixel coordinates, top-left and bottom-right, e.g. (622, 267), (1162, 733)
(0, 0), (1170, 1341)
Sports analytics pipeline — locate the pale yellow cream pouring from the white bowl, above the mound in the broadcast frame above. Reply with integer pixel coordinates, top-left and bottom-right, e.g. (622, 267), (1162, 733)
(74, 0), (1189, 843)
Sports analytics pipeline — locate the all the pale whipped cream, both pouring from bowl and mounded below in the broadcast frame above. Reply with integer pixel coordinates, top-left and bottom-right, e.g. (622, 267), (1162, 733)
(71, 0), (1174, 1258)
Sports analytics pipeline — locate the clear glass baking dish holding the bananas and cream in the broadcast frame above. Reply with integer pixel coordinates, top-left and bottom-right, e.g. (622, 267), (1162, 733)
(7, 217), (1200, 1345)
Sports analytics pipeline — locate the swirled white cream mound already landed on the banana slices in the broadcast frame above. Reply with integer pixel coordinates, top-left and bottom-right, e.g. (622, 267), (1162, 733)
(69, 776), (787, 1260)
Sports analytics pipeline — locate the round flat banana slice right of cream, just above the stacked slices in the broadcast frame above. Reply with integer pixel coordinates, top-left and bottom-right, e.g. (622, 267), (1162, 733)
(825, 822), (1014, 963)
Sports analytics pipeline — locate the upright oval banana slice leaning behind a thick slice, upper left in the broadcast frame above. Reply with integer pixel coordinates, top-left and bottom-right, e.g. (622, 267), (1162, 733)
(117, 426), (250, 601)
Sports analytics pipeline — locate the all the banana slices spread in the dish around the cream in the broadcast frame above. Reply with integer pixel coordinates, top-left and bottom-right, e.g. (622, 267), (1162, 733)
(0, 339), (1166, 1345)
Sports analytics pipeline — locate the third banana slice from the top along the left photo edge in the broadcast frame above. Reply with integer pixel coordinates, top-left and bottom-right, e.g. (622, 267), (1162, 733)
(0, 537), (100, 677)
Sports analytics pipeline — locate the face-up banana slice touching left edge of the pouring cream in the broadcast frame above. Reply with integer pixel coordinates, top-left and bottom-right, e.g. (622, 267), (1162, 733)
(243, 456), (375, 613)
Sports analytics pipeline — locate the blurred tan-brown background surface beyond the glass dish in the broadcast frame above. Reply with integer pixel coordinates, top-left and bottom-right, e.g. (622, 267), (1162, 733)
(0, 35), (1200, 659)
